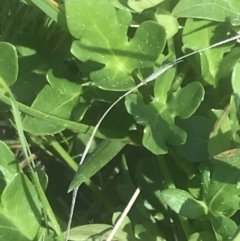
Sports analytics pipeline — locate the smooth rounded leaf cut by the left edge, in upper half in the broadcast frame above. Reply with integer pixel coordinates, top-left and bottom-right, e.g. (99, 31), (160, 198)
(0, 42), (18, 86)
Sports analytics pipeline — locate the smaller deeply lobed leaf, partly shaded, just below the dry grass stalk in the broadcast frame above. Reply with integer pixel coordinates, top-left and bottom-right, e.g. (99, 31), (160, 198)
(125, 71), (204, 154)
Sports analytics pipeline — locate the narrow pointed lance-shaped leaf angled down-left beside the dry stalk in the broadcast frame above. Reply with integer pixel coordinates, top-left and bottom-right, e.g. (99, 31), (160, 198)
(69, 141), (125, 192)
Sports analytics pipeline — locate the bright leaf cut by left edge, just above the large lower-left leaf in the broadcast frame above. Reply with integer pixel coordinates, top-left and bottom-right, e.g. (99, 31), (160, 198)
(0, 141), (19, 193)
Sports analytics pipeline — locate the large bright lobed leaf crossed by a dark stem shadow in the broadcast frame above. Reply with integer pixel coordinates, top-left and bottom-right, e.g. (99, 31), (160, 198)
(65, 0), (166, 91)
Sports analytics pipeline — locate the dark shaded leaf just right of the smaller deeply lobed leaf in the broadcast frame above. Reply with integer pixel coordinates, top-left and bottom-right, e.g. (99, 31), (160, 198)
(175, 116), (212, 162)
